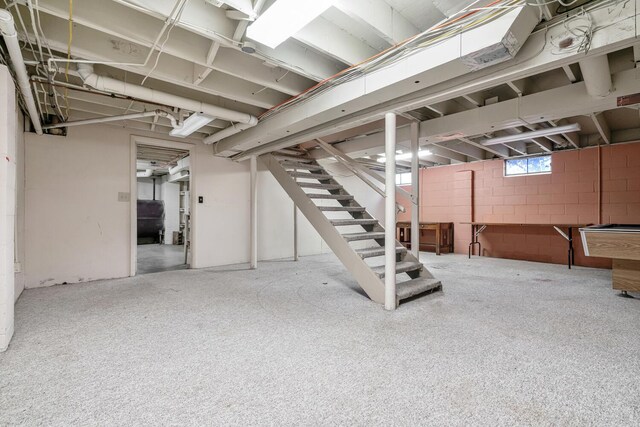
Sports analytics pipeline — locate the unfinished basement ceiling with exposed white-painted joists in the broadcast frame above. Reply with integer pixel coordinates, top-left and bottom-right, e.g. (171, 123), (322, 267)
(4, 0), (640, 165)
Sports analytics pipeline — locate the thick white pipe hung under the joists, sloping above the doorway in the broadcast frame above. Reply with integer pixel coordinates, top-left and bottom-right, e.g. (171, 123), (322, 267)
(78, 64), (258, 127)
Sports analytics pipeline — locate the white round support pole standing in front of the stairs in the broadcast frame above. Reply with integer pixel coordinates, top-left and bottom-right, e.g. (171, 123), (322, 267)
(384, 113), (396, 310)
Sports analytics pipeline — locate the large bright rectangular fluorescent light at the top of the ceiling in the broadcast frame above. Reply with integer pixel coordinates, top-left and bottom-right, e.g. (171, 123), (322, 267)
(247, 0), (334, 49)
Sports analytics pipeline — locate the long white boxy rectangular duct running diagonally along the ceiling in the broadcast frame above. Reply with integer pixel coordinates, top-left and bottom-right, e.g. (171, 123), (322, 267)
(210, 6), (539, 160)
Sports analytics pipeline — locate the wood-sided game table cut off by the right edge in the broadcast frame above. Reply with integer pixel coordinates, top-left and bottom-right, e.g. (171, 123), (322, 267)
(580, 224), (640, 294)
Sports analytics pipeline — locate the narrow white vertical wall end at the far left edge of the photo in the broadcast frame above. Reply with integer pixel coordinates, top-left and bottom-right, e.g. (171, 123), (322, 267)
(0, 65), (17, 351)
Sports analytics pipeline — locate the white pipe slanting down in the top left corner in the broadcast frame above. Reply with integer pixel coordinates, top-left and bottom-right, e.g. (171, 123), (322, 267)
(0, 9), (42, 135)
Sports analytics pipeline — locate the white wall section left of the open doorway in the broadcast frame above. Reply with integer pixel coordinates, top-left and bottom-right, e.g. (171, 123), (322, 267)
(24, 127), (130, 288)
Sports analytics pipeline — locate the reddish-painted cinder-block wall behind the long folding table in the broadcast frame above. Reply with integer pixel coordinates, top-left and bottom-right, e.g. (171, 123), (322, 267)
(399, 143), (640, 267)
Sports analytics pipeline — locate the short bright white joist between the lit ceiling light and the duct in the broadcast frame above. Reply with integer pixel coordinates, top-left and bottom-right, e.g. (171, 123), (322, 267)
(335, 0), (420, 45)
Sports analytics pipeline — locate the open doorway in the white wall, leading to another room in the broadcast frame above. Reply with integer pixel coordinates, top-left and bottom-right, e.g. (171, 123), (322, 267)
(136, 143), (191, 274)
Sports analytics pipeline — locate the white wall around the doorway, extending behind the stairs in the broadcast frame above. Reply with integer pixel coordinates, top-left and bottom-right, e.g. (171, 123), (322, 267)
(23, 125), (325, 287)
